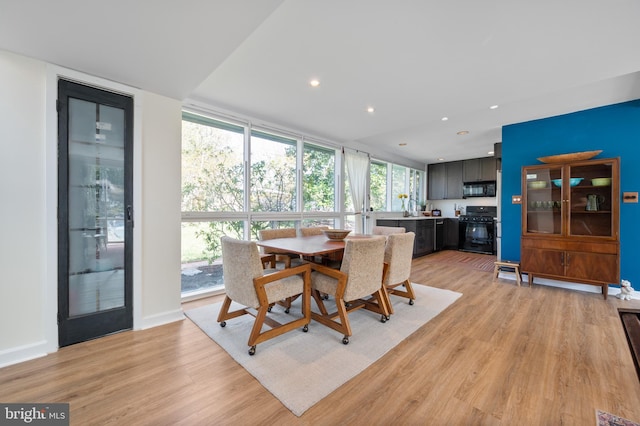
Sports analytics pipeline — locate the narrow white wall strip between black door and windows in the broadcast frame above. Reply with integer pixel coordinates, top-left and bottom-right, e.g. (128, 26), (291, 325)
(136, 93), (183, 328)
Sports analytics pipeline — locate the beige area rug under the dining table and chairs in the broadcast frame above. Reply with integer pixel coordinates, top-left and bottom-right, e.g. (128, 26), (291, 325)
(185, 284), (462, 416)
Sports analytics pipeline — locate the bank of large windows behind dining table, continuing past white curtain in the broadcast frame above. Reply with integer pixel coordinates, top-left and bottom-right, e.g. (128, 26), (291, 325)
(182, 112), (424, 296)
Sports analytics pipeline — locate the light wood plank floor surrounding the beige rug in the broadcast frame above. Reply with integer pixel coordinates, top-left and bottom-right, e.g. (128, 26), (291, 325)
(0, 254), (640, 425)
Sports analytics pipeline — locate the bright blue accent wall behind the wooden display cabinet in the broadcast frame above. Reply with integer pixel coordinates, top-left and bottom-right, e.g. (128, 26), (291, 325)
(500, 99), (640, 290)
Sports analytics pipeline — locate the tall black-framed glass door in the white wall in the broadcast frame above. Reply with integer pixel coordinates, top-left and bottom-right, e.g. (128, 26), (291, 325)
(58, 80), (133, 346)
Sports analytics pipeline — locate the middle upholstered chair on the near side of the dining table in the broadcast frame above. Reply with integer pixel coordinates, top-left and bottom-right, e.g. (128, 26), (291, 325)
(311, 236), (389, 345)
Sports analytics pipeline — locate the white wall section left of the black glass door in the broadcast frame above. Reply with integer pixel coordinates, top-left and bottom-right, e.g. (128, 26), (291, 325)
(0, 51), (46, 365)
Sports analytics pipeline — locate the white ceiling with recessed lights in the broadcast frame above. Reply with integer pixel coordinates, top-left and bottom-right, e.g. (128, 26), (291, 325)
(0, 0), (640, 163)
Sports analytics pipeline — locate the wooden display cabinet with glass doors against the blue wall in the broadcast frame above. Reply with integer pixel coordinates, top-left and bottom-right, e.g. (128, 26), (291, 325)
(520, 158), (620, 299)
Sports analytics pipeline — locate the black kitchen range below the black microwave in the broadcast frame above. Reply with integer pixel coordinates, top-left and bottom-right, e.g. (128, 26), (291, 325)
(458, 206), (498, 254)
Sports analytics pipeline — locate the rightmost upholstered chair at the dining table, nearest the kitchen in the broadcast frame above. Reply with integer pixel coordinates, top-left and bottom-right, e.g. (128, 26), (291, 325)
(382, 232), (416, 313)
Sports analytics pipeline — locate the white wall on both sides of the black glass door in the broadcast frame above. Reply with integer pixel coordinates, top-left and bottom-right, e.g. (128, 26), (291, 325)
(0, 51), (183, 367)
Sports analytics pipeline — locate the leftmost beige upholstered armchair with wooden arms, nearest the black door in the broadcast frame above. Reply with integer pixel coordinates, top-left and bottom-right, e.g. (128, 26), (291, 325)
(218, 237), (311, 355)
